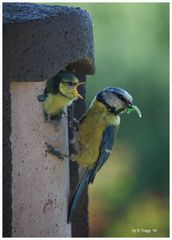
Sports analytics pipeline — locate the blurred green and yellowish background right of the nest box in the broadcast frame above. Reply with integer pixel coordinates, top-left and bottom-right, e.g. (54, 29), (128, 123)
(49, 3), (169, 237)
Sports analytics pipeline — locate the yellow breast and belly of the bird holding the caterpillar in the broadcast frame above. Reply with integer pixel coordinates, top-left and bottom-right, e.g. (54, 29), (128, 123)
(74, 102), (120, 168)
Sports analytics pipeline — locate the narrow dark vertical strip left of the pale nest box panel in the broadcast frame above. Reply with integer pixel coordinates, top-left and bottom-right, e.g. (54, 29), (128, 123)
(3, 76), (12, 237)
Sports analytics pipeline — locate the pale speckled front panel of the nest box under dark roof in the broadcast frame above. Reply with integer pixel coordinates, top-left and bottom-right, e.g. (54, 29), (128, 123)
(11, 82), (71, 237)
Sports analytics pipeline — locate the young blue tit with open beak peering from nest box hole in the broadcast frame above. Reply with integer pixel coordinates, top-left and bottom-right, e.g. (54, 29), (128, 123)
(38, 70), (85, 119)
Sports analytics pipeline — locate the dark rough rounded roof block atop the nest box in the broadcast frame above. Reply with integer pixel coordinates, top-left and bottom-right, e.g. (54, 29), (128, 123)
(3, 3), (94, 81)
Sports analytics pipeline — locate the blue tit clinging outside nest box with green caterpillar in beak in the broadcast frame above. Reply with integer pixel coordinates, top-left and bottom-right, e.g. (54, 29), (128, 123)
(68, 87), (141, 222)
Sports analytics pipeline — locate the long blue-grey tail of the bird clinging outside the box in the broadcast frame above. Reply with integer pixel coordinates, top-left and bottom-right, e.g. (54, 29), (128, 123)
(68, 169), (90, 223)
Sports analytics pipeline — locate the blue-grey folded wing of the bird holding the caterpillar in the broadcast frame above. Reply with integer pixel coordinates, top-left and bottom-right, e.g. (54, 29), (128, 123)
(89, 126), (118, 183)
